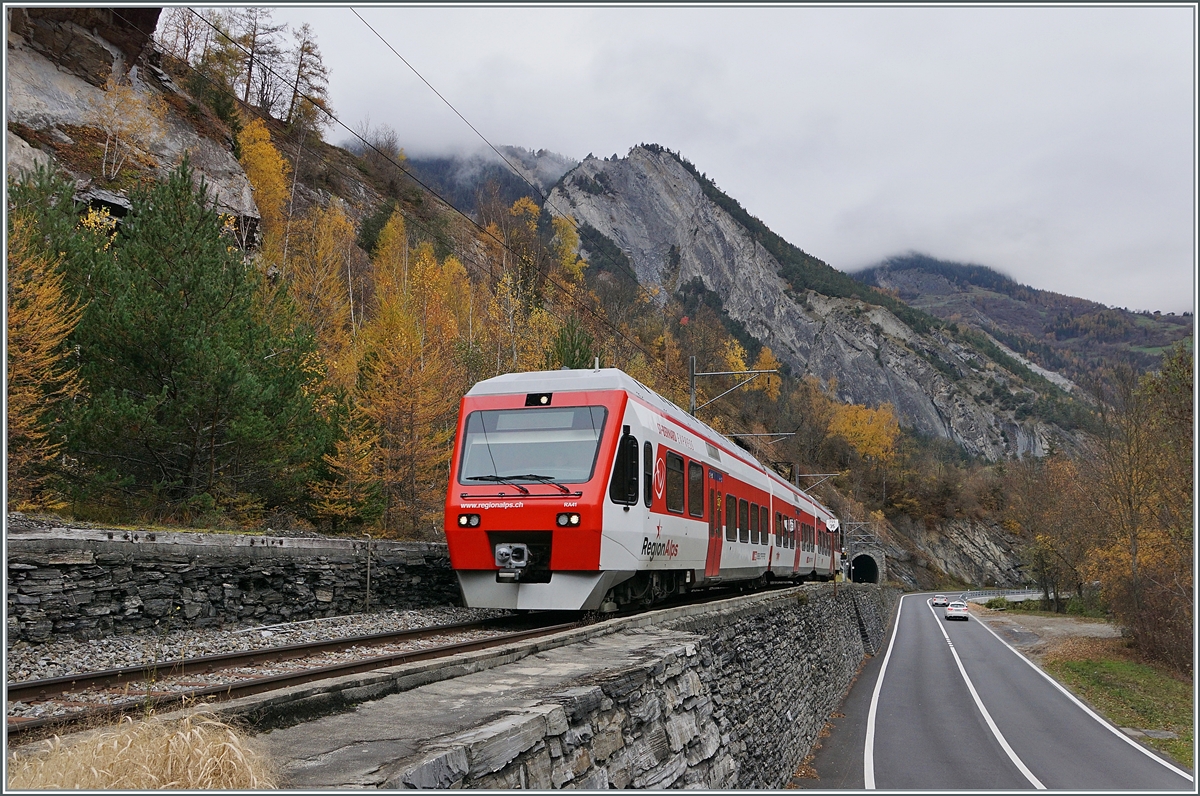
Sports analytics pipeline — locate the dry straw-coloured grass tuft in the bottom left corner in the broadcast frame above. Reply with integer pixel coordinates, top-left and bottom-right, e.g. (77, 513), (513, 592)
(8, 716), (277, 790)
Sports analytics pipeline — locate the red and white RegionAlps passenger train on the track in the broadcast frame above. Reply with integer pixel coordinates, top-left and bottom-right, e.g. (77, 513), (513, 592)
(445, 369), (841, 611)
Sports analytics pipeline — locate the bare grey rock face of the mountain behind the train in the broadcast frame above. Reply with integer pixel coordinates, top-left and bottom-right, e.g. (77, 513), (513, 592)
(547, 146), (1063, 460)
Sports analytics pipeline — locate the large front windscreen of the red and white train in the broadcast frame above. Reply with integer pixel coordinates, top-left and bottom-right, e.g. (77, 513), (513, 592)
(458, 406), (608, 485)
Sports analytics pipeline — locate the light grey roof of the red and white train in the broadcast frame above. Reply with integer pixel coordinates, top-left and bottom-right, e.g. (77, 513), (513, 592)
(467, 367), (833, 515)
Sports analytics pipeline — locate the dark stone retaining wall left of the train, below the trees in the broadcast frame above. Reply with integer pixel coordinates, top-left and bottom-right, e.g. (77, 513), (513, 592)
(6, 528), (461, 644)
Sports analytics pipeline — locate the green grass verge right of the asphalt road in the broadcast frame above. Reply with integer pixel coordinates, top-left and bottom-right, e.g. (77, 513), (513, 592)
(1042, 638), (1195, 770)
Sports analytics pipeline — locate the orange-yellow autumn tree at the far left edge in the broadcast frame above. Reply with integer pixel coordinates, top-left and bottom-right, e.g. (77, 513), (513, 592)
(6, 216), (80, 510)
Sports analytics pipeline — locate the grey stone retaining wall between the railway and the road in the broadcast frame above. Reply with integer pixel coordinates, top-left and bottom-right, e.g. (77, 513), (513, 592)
(385, 585), (899, 789)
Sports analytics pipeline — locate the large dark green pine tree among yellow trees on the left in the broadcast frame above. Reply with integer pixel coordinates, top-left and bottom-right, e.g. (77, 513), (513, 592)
(59, 160), (328, 513)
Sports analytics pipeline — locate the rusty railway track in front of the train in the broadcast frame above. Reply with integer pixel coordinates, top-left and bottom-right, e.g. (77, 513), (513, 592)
(7, 617), (578, 741)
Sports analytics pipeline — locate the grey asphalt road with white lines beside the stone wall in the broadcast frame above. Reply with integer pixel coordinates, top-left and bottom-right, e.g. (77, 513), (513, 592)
(796, 594), (1195, 792)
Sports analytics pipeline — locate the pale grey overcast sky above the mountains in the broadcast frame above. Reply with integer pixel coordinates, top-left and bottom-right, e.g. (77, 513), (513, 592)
(267, 5), (1196, 312)
